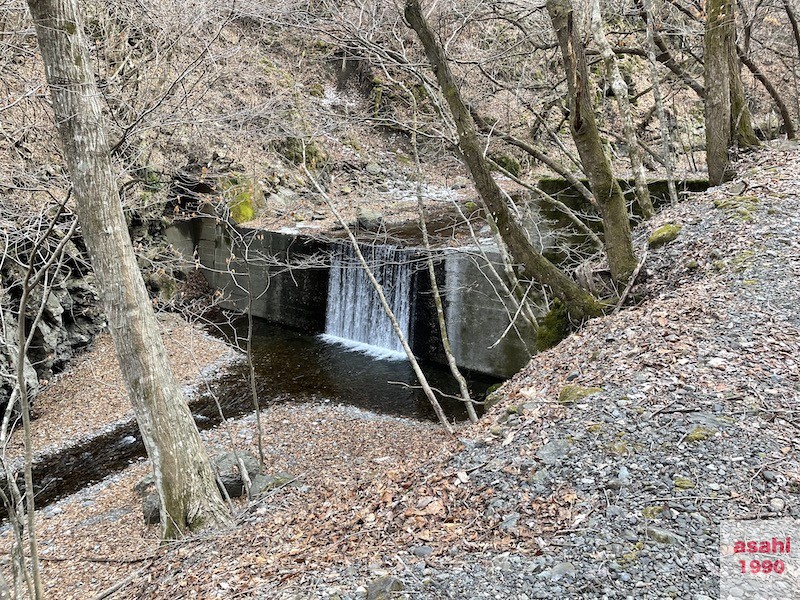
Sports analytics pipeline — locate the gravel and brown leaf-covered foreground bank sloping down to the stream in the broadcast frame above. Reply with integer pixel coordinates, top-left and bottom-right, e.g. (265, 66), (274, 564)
(1, 144), (800, 600)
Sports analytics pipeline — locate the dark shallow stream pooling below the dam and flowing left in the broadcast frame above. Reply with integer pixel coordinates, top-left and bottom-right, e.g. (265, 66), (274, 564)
(12, 320), (498, 508)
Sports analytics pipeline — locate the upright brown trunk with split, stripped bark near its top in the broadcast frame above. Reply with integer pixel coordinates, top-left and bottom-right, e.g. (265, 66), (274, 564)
(547, 0), (638, 289)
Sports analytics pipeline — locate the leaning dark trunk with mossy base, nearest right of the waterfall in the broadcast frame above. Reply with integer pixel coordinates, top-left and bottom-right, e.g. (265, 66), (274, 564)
(405, 0), (603, 321)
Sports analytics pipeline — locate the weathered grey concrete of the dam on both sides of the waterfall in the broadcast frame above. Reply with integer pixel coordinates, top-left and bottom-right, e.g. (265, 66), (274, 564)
(168, 216), (535, 377)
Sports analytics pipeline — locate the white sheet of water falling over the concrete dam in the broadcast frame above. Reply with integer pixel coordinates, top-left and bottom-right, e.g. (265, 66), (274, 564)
(323, 243), (412, 359)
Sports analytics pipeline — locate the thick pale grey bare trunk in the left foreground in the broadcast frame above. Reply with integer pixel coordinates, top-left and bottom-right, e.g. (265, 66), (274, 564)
(28, 0), (231, 539)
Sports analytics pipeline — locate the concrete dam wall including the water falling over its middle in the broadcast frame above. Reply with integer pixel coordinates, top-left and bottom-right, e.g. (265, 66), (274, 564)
(167, 216), (535, 377)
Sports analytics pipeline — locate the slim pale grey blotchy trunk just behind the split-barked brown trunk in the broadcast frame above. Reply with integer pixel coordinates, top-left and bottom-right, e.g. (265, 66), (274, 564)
(591, 0), (655, 219)
